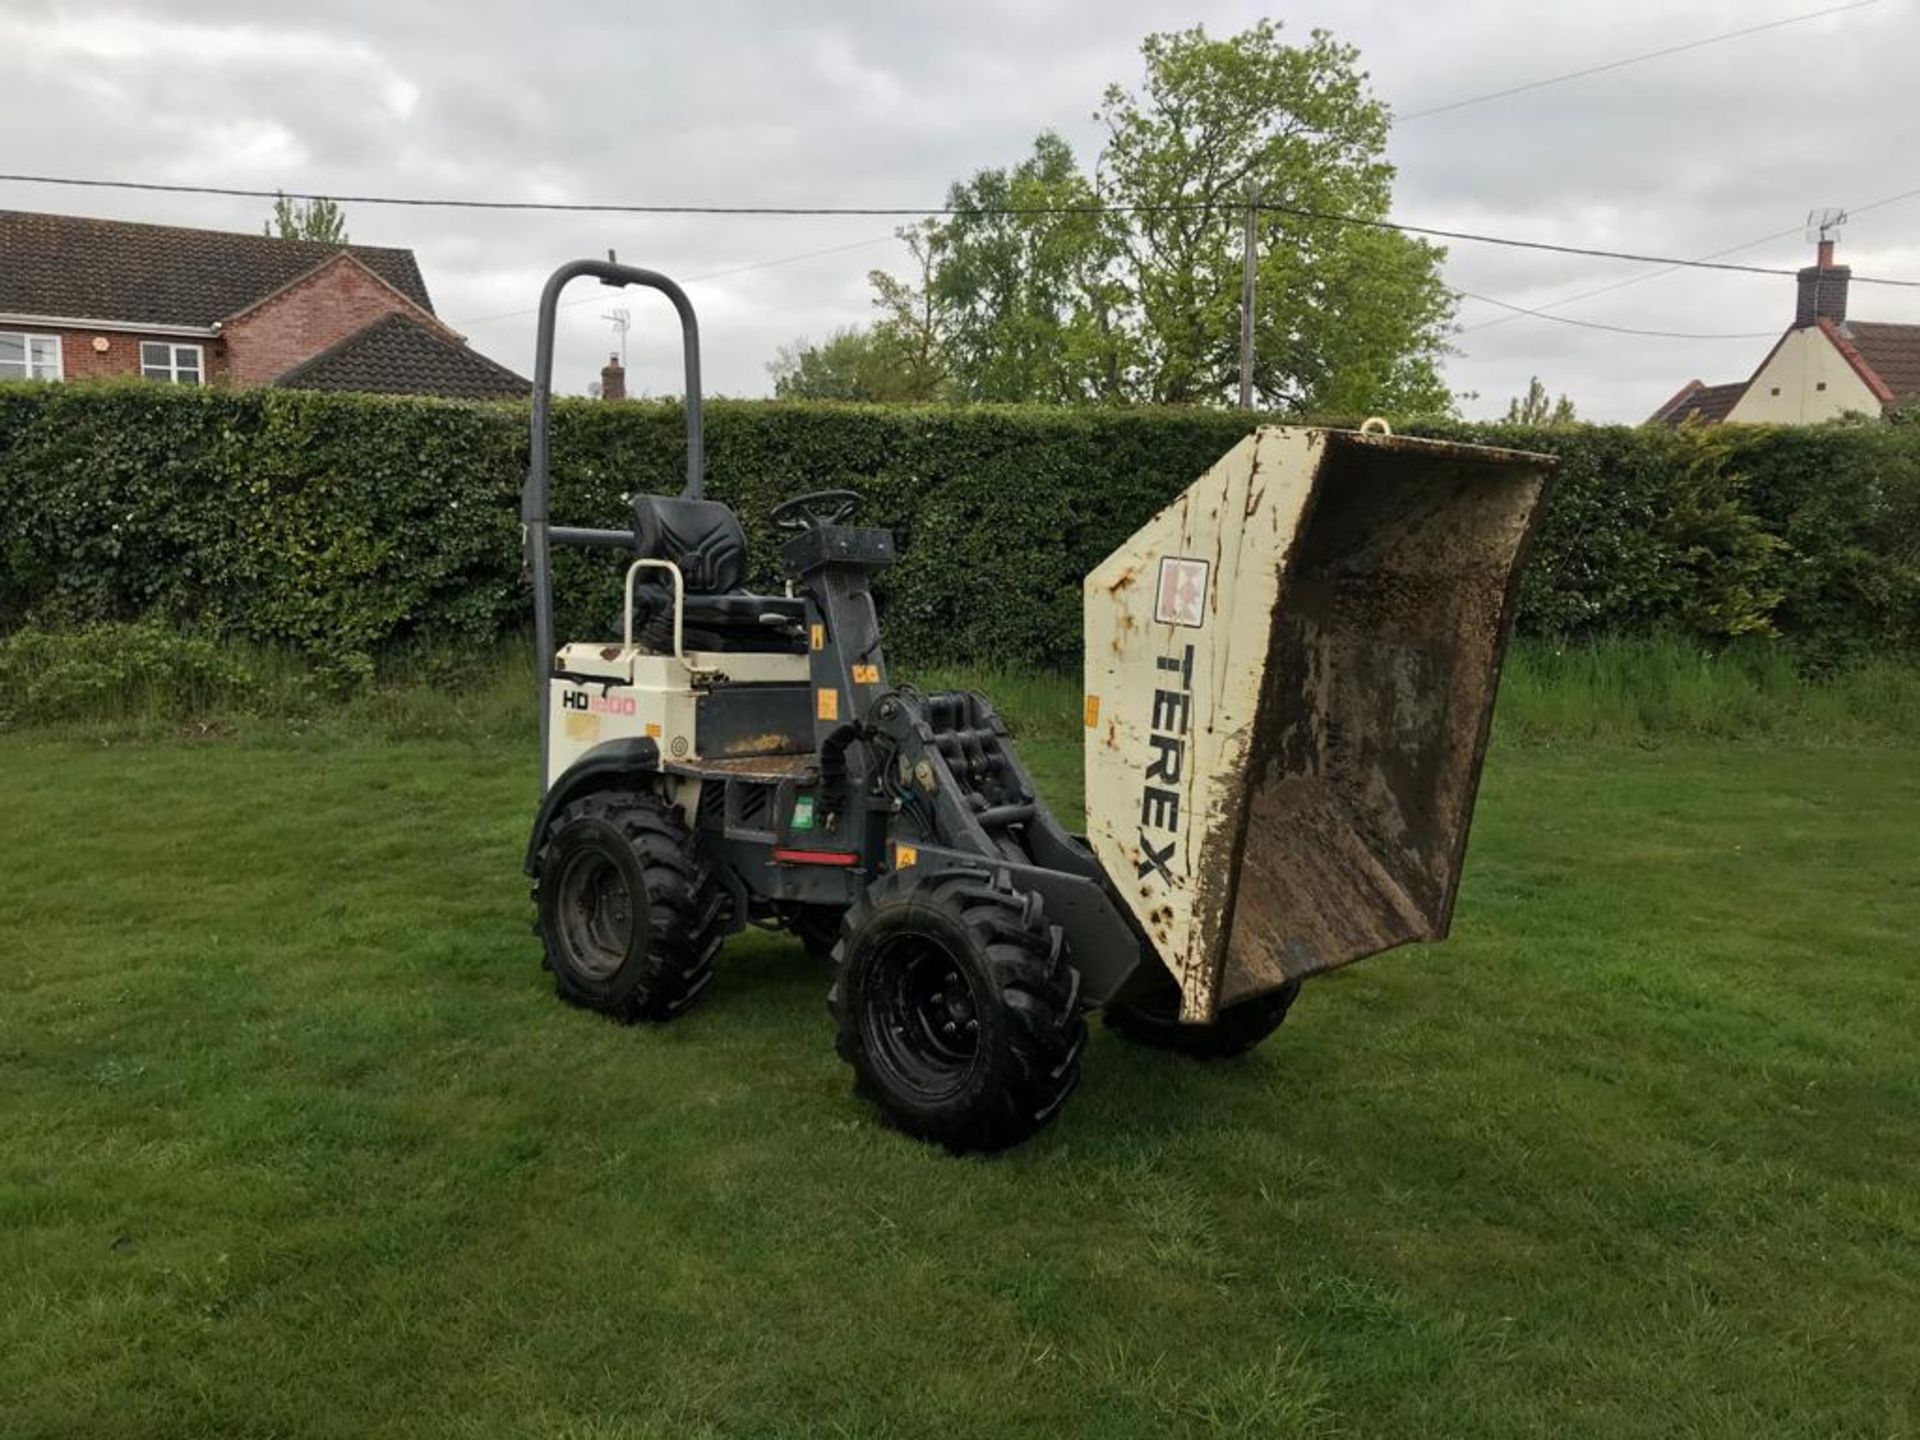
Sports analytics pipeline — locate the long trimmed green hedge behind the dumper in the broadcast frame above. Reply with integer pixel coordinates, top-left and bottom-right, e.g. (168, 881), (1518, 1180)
(0, 384), (1920, 680)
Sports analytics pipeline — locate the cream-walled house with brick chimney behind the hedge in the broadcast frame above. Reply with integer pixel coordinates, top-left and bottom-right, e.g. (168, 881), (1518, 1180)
(1647, 240), (1920, 424)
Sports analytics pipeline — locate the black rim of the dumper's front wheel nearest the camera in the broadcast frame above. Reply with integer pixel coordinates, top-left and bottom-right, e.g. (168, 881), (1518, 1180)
(860, 935), (981, 1100)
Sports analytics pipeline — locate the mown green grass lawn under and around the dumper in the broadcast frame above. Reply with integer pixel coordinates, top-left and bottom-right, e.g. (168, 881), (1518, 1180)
(0, 695), (1920, 1440)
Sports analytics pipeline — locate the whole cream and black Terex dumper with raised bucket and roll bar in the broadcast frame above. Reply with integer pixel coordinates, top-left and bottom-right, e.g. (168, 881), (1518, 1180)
(522, 261), (1549, 1150)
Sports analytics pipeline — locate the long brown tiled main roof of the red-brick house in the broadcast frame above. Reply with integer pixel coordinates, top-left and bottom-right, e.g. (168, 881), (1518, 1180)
(0, 209), (434, 326)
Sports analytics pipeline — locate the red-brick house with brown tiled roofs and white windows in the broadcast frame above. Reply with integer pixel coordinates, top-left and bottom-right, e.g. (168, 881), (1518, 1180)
(0, 211), (530, 399)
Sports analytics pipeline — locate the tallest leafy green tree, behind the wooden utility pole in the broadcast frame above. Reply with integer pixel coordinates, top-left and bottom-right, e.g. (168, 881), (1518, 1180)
(1100, 21), (1453, 411)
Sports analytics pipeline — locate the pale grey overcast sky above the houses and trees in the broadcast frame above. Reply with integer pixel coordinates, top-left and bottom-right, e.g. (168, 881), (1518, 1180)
(0, 0), (1920, 420)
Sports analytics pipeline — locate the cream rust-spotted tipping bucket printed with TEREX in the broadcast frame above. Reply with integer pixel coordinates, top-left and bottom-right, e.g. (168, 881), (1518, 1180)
(1085, 428), (1553, 1021)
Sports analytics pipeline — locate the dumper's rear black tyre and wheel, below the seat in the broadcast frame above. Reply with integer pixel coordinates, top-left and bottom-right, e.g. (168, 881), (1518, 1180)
(534, 791), (720, 1020)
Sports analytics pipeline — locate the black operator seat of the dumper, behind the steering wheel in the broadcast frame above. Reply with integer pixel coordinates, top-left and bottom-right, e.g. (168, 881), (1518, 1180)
(634, 495), (806, 655)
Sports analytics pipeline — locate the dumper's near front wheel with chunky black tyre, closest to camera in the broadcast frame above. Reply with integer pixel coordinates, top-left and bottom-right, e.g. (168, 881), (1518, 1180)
(828, 870), (1087, 1152)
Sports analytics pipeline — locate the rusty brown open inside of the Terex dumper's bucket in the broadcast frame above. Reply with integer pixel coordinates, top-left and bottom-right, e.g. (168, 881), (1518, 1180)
(1215, 432), (1549, 1004)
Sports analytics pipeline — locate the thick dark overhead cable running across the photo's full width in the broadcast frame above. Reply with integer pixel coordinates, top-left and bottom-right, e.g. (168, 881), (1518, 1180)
(0, 175), (1920, 290)
